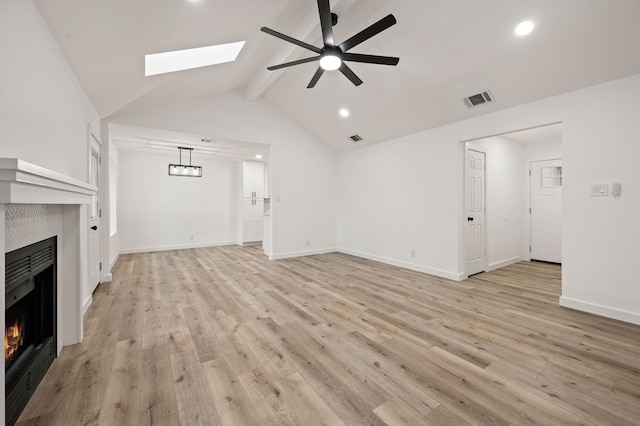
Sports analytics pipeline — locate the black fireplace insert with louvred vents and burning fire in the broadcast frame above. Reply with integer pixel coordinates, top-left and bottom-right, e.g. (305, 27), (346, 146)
(4, 237), (57, 425)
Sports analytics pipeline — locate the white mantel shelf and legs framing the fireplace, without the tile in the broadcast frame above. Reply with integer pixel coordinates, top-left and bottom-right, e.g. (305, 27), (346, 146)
(0, 158), (97, 423)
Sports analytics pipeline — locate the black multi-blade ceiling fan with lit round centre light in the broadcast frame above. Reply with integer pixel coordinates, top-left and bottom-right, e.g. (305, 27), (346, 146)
(261, 0), (400, 89)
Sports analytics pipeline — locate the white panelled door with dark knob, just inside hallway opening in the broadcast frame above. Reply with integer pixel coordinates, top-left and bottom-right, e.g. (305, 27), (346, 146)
(464, 147), (487, 275)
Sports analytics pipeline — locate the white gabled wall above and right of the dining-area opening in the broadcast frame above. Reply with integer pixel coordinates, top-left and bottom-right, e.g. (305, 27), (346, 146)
(109, 93), (337, 258)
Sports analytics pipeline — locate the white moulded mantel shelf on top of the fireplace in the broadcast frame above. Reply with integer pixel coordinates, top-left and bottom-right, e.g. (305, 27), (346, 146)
(0, 158), (98, 204)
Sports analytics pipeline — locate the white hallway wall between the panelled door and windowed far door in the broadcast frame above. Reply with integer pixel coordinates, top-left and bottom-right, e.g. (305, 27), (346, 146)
(472, 136), (524, 270)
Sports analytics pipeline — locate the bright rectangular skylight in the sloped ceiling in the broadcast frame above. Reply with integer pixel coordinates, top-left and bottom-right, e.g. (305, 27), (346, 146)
(144, 41), (245, 76)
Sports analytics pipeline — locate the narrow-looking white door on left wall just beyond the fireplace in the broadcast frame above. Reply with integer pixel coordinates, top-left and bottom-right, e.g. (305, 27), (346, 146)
(89, 133), (102, 293)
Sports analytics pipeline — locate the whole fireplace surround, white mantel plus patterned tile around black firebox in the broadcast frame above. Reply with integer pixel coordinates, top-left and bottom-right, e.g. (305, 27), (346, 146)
(0, 158), (96, 423)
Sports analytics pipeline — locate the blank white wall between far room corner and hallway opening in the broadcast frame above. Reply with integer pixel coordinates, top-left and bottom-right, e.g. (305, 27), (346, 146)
(338, 133), (462, 279)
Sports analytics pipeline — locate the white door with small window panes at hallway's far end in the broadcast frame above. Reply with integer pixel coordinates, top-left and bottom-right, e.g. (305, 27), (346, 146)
(531, 160), (562, 263)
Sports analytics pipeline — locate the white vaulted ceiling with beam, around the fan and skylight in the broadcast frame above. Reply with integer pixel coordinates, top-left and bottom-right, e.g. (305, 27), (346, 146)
(35, 0), (640, 151)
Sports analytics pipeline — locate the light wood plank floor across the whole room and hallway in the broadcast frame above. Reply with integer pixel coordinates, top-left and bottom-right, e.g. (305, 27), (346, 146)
(19, 246), (640, 426)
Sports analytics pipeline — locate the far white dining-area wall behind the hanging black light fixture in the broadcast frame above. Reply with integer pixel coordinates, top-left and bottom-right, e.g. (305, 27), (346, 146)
(117, 149), (239, 253)
